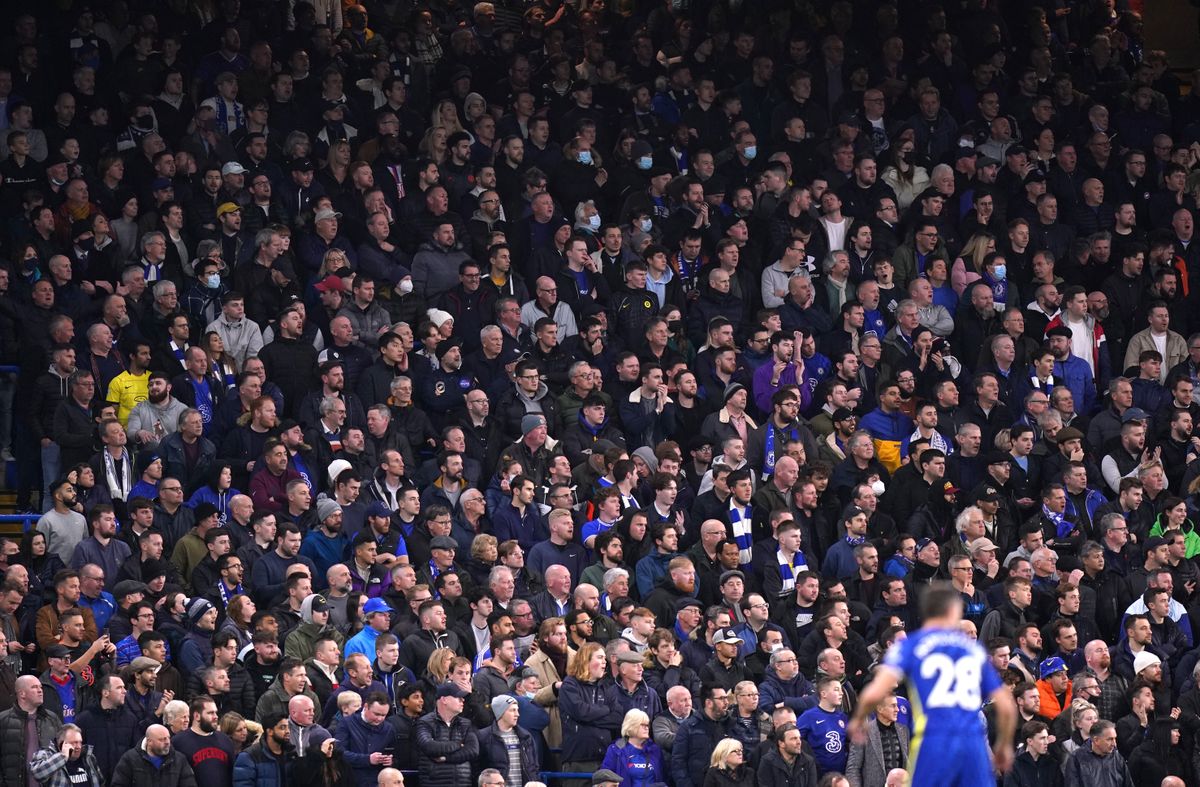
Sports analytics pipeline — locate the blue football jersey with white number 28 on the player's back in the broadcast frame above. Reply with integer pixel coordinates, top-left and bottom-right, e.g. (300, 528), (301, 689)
(883, 629), (1002, 745)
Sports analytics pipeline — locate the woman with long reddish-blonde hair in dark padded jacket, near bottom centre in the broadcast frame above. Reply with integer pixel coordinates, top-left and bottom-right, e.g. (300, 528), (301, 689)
(558, 642), (624, 783)
